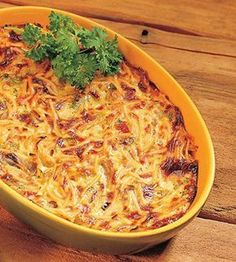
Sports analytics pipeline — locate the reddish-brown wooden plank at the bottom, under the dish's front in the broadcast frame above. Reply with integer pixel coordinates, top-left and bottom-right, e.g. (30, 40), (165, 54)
(0, 209), (236, 262)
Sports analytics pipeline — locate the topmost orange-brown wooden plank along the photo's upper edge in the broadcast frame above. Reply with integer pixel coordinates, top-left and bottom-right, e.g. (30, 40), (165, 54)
(0, 0), (236, 39)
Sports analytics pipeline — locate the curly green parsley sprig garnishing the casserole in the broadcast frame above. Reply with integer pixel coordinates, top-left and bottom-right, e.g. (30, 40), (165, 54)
(22, 12), (123, 89)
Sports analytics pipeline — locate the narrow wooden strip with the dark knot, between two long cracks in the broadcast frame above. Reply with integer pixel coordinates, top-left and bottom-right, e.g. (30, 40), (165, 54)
(93, 19), (236, 58)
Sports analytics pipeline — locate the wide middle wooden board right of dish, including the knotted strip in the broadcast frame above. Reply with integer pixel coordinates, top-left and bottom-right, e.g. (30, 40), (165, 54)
(0, 1), (236, 223)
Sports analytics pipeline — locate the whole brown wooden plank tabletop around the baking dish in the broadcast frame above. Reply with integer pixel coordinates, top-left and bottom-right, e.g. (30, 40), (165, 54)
(0, 0), (236, 262)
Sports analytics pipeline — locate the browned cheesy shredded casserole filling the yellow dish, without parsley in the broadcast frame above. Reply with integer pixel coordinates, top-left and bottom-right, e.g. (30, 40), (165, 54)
(0, 26), (198, 232)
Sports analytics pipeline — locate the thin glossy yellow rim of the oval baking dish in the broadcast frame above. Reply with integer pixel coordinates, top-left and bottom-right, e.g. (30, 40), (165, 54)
(0, 5), (215, 239)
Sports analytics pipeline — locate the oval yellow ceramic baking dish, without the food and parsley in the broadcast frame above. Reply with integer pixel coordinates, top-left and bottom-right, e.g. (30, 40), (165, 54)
(0, 6), (215, 254)
